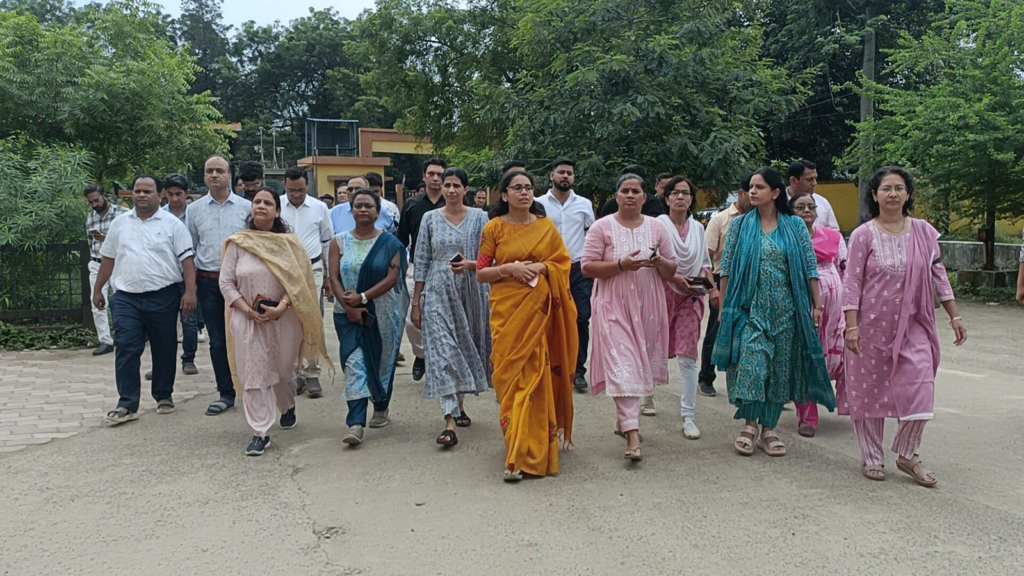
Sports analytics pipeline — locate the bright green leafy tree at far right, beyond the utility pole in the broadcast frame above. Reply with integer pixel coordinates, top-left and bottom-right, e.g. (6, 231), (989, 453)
(848, 0), (1024, 264)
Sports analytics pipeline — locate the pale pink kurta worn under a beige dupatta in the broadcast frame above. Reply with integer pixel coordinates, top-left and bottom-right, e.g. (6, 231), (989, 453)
(220, 242), (302, 389)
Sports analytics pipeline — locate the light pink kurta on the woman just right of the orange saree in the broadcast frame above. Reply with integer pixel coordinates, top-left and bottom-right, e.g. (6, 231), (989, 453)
(581, 215), (676, 397)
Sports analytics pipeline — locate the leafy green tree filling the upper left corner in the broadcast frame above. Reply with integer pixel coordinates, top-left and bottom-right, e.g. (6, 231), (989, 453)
(0, 0), (226, 179)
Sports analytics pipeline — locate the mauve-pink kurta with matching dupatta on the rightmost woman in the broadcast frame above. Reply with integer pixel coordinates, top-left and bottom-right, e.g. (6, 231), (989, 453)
(843, 218), (953, 420)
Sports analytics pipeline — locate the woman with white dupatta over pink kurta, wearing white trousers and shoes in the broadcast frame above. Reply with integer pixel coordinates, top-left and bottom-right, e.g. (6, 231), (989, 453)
(657, 176), (719, 440)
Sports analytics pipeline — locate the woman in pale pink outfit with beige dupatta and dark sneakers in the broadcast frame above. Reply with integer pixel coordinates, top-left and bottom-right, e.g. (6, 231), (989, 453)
(220, 188), (333, 456)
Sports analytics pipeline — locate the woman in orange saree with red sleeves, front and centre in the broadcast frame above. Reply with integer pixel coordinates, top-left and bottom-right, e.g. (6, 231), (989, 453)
(476, 170), (579, 482)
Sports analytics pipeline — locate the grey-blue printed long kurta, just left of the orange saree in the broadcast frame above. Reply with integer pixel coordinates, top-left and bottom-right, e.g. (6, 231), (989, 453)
(413, 208), (490, 399)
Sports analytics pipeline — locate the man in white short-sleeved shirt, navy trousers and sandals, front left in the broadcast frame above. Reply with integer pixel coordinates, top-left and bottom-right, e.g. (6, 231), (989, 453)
(92, 175), (196, 424)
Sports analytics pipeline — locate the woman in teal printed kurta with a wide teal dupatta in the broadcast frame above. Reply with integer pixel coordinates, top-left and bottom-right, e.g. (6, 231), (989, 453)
(712, 167), (836, 456)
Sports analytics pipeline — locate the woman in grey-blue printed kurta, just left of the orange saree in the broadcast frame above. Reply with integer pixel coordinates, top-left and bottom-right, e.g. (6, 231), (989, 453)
(412, 167), (492, 446)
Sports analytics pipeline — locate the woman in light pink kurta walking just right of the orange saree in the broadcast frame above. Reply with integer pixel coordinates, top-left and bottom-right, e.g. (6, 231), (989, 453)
(581, 174), (676, 460)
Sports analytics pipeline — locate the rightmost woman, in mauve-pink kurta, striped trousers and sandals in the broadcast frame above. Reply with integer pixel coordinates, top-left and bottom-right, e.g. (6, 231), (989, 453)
(843, 166), (967, 486)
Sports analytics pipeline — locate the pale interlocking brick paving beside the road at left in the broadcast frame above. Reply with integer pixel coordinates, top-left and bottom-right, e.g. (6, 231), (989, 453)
(0, 343), (216, 453)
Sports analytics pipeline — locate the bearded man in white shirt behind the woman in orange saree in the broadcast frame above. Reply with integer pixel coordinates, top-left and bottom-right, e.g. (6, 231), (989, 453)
(537, 158), (595, 393)
